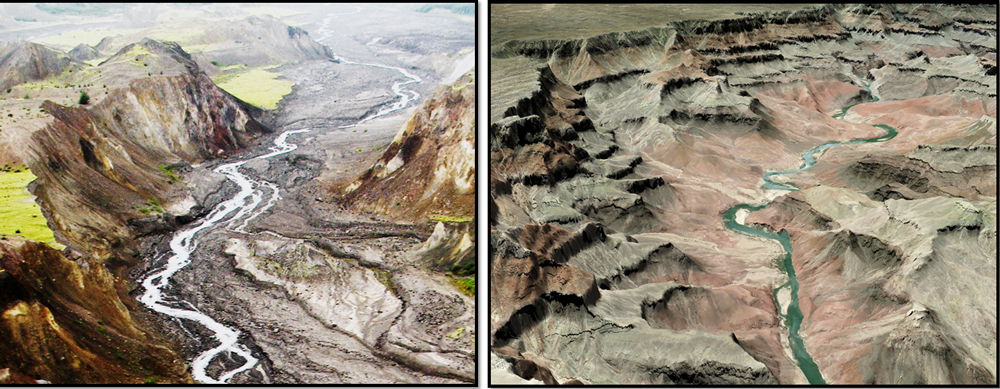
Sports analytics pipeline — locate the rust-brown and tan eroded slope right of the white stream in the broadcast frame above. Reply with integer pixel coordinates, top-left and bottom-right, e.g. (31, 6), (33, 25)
(342, 72), (476, 221)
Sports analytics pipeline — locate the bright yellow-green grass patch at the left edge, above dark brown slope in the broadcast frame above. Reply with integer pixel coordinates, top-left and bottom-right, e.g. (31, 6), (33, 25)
(0, 166), (64, 249)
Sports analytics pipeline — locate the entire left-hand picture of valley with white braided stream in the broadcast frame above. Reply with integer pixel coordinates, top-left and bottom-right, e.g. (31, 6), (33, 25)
(0, 4), (476, 384)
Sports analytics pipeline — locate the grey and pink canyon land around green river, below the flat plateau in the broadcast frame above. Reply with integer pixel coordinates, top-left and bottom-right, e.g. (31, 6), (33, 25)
(489, 4), (997, 385)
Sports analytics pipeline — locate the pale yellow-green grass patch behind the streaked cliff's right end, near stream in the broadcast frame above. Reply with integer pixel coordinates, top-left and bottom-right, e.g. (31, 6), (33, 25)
(212, 65), (295, 109)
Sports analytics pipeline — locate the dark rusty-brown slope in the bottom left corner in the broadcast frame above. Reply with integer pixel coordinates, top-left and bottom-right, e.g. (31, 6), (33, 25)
(0, 237), (190, 385)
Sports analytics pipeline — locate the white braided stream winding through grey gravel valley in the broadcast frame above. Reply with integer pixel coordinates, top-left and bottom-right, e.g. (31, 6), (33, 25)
(139, 56), (421, 384)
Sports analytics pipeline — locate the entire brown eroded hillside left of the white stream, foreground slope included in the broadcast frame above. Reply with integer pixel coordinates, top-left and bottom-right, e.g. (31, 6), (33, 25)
(0, 35), (267, 384)
